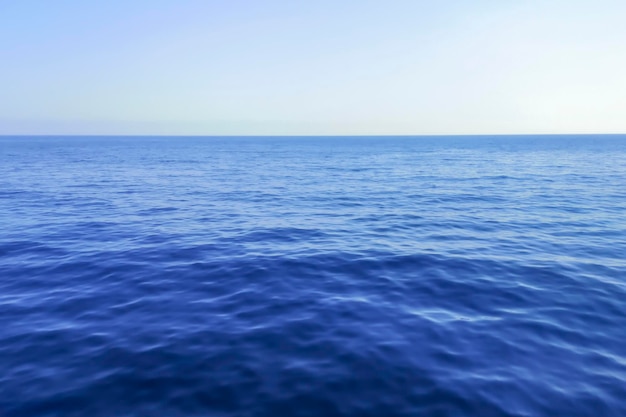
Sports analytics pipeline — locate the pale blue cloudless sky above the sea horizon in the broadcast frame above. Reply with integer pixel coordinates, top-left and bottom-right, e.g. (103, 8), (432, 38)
(0, 0), (626, 135)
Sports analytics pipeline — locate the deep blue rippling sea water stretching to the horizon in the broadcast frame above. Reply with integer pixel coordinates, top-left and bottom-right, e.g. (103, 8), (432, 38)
(0, 135), (626, 417)
